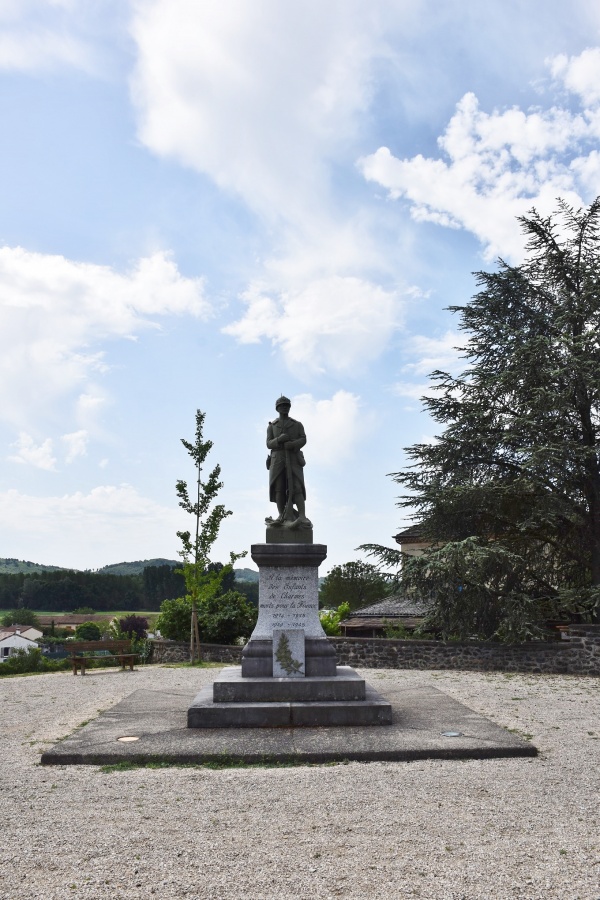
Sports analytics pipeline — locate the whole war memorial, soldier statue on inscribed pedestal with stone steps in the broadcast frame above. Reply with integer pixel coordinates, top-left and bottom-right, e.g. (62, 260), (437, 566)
(188, 396), (392, 728)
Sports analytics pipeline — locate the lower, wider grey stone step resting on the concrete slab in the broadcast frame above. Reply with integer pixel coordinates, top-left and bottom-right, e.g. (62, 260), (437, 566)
(187, 685), (392, 728)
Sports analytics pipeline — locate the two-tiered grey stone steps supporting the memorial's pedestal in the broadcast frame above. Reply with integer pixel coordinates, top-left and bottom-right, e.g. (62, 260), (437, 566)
(187, 666), (392, 728)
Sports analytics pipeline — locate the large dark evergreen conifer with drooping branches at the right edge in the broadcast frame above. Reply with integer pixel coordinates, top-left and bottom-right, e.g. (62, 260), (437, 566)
(362, 198), (600, 640)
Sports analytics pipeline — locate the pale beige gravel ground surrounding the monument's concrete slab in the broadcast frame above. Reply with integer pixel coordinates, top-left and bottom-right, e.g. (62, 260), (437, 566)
(0, 666), (600, 900)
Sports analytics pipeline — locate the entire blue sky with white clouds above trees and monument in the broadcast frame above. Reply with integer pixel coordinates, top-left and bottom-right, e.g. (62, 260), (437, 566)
(0, 0), (600, 571)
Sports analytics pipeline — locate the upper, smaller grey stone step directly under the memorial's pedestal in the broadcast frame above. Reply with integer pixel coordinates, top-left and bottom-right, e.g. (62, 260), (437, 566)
(213, 666), (365, 703)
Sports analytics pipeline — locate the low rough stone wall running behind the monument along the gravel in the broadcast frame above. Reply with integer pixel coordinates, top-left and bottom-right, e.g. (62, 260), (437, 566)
(151, 625), (600, 675)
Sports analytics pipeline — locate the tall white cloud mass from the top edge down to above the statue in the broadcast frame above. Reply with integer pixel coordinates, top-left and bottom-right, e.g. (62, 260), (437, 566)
(132, 0), (412, 372)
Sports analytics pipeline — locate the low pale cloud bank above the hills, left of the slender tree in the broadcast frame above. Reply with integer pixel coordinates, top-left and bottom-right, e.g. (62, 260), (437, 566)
(0, 484), (182, 568)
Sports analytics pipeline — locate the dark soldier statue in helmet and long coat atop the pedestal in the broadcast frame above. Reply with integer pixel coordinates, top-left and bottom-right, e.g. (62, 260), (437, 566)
(266, 396), (312, 529)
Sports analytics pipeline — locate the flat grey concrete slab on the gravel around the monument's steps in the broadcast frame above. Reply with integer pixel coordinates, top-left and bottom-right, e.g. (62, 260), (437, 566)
(41, 681), (537, 765)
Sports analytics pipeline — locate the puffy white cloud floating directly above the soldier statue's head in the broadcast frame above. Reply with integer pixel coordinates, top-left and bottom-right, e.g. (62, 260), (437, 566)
(225, 276), (400, 376)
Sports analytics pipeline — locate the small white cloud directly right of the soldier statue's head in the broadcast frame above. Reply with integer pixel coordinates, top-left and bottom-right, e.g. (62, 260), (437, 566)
(290, 391), (370, 466)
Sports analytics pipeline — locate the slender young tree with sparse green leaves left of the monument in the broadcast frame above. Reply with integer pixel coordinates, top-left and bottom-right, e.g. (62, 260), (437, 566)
(176, 409), (246, 662)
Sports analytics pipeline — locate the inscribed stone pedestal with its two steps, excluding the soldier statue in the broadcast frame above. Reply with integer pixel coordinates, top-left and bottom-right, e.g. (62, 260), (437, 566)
(188, 543), (392, 728)
